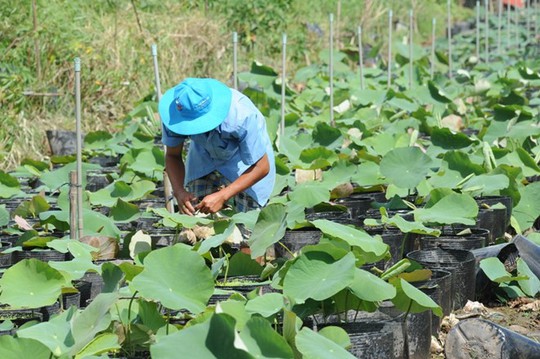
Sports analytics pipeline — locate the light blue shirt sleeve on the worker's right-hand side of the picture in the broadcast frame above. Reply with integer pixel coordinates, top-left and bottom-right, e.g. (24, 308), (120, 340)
(237, 113), (268, 166)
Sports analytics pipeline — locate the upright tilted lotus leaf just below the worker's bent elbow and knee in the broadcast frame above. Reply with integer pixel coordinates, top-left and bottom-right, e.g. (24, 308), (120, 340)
(248, 203), (287, 259)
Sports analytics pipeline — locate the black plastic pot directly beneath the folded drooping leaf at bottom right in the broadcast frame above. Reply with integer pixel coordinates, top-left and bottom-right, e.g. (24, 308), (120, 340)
(379, 301), (432, 359)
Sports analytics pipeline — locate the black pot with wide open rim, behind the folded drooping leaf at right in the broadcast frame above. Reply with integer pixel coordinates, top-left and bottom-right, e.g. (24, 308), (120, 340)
(407, 248), (476, 309)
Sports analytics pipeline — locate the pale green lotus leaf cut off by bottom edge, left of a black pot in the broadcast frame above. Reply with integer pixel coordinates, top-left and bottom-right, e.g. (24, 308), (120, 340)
(296, 327), (354, 359)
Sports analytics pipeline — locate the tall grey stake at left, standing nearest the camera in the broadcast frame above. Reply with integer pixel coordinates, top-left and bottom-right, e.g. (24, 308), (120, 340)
(75, 57), (83, 239)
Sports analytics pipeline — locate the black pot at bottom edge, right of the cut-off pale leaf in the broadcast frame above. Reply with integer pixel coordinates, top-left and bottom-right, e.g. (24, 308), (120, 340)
(317, 319), (394, 359)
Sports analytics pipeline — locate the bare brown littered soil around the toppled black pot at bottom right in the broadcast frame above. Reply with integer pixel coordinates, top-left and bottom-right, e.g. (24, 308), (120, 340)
(431, 298), (540, 359)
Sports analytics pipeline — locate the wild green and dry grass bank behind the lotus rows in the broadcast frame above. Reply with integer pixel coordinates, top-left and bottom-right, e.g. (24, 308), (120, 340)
(0, 0), (468, 170)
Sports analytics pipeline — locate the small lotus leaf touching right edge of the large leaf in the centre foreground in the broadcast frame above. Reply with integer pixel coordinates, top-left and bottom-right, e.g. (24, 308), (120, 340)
(349, 268), (396, 302)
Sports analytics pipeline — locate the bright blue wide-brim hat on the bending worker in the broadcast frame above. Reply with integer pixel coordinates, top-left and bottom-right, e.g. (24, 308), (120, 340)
(159, 78), (232, 135)
